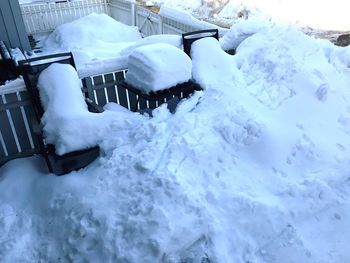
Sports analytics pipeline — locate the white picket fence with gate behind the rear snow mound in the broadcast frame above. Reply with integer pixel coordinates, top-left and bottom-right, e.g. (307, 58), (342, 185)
(21, 0), (224, 36)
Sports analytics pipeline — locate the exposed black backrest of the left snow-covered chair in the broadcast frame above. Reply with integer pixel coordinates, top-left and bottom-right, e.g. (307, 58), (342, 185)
(18, 52), (76, 121)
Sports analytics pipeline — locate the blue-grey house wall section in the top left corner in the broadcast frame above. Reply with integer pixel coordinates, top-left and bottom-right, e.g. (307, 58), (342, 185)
(0, 0), (31, 51)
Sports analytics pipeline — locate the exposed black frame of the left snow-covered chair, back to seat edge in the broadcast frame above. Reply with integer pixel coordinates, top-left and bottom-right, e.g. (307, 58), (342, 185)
(19, 53), (103, 175)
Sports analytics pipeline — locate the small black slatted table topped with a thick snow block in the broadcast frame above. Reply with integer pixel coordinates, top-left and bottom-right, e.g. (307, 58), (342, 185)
(119, 43), (201, 115)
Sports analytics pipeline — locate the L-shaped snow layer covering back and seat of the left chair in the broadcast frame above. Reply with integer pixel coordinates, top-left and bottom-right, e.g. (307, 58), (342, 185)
(38, 63), (137, 155)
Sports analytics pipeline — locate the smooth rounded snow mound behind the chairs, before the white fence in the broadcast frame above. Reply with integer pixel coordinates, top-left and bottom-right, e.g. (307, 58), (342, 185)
(43, 13), (141, 67)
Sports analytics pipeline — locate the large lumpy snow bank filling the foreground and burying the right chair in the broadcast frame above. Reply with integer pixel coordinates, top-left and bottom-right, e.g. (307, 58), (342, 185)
(0, 18), (350, 263)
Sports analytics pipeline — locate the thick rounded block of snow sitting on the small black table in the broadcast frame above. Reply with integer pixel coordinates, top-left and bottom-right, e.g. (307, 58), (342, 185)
(125, 43), (192, 93)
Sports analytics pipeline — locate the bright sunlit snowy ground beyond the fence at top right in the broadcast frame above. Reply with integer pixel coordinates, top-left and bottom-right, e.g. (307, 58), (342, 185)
(144, 0), (350, 31)
